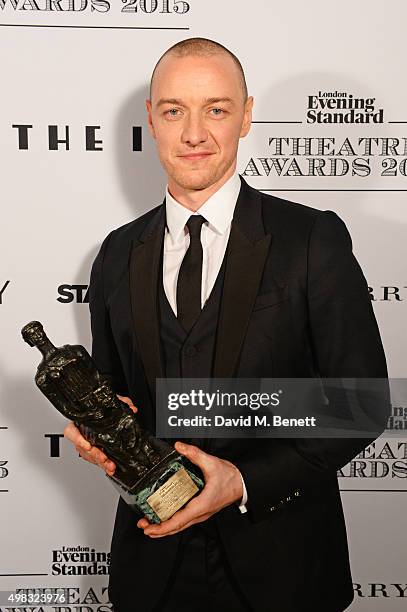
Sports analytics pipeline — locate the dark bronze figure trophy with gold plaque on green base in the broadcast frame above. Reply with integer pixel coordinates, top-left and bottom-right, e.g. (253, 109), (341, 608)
(21, 321), (204, 523)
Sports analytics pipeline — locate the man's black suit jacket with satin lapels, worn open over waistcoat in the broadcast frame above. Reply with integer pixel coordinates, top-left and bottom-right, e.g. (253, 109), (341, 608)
(89, 177), (387, 612)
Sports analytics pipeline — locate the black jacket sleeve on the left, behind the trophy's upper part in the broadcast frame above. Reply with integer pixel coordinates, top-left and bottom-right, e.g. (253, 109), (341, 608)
(89, 232), (128, 396)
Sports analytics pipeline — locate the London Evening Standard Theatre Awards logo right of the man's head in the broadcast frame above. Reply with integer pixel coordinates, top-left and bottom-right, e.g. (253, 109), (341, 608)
(242, 90), (407, 179)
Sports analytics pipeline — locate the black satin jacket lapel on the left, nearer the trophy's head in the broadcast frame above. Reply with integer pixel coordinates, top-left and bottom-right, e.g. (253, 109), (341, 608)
(129, 204), (165, 401)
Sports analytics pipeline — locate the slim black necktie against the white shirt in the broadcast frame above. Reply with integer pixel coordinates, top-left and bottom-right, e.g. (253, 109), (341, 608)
(177, 215), (206, 332)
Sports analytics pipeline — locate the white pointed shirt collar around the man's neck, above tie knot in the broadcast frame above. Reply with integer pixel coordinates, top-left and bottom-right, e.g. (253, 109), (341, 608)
(165, 171), (241, 242)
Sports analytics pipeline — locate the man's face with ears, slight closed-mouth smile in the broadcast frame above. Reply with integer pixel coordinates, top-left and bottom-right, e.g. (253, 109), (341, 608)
(146, 54), (253, 190)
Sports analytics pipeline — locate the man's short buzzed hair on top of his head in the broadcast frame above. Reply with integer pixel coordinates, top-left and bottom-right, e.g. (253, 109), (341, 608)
(150, 38), (248, 102)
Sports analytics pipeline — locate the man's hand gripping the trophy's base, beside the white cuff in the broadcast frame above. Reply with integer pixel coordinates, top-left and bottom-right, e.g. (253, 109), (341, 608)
(137, 442), (243, 538)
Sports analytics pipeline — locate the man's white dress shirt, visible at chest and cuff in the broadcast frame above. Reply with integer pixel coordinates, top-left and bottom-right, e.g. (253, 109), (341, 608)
(163, 172), (247, 512)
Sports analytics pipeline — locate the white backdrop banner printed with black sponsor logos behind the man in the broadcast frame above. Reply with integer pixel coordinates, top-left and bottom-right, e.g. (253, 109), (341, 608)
(0, 0), (407, 612)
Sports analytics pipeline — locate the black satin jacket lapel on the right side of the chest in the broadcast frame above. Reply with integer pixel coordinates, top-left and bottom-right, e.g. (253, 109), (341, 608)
(213, 177), (271, 378)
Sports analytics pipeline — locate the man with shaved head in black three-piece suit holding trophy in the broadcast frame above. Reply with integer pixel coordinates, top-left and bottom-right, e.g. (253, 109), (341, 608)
(65, 39), (387, 612)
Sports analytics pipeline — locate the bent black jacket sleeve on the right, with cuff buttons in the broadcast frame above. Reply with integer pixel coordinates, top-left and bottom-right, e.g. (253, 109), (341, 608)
(234, 211), (390, 522)
